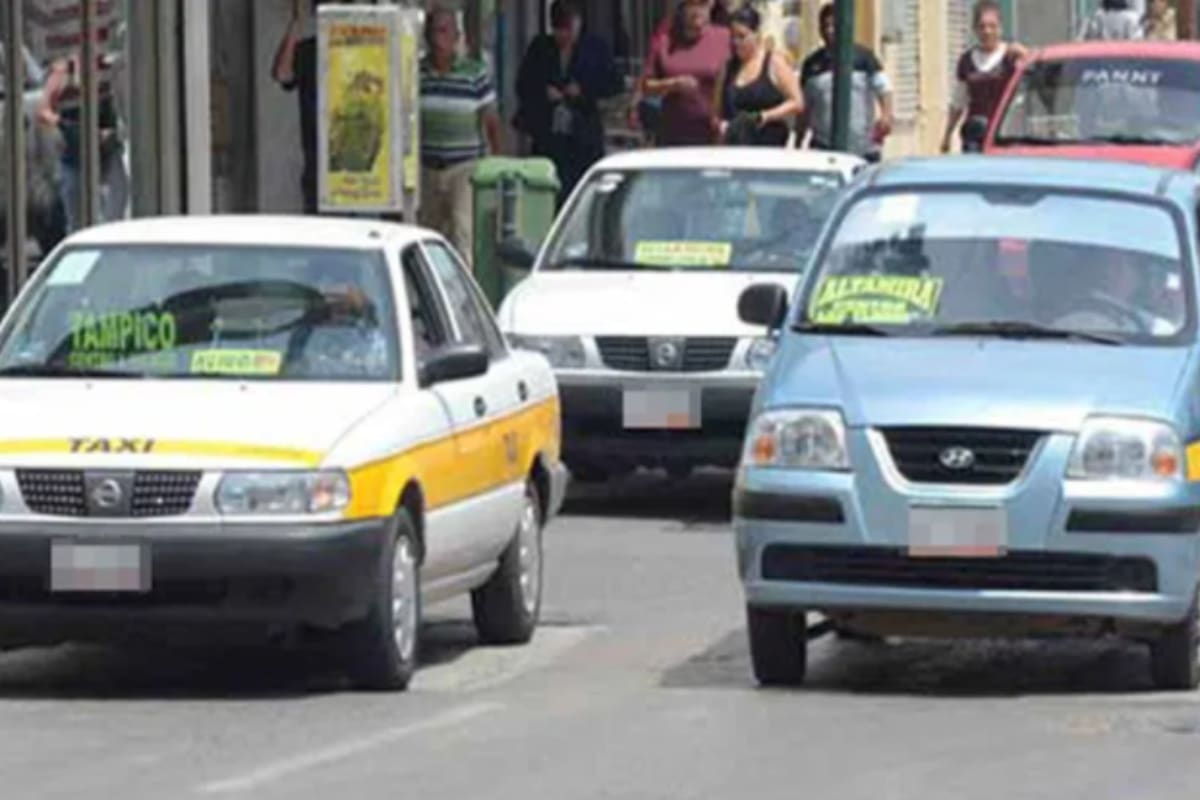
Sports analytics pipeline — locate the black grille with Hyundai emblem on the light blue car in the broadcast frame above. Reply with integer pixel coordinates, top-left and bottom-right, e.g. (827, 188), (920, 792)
(883, 428), (1042, 485)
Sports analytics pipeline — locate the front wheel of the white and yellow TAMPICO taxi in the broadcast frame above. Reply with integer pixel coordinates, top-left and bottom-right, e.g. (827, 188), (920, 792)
(342, 510), (421, 692)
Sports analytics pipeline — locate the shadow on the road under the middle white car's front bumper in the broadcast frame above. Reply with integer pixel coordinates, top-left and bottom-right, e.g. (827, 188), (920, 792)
(563, 470), (733, 524)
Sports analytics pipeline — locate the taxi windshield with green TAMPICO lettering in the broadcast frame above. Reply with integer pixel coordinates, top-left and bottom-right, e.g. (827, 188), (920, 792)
(0, 246), (400, 380)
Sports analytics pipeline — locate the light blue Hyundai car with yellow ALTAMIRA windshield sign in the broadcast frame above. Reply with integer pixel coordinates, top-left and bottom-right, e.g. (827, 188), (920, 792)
(734, 156), (1200, 690)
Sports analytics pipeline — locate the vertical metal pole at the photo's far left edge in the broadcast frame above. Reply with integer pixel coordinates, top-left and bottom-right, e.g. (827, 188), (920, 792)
(4, 2), (28, 302)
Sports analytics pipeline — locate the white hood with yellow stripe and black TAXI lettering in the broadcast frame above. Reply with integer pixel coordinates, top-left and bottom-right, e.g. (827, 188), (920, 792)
(0, 379), (396, 469)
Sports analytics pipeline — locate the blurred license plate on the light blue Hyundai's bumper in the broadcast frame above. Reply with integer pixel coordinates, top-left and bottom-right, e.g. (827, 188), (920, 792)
(908, 506), (1008, 558)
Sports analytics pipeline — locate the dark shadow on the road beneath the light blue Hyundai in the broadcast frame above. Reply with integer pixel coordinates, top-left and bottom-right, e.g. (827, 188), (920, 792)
(660, 628), (1151, 698)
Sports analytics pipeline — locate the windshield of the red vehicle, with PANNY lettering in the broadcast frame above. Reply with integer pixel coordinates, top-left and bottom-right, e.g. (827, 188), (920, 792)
(996, 58), (1200, 144)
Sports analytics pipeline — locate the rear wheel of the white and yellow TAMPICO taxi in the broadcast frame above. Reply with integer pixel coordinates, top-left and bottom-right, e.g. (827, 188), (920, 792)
(470, 480), (544, 644)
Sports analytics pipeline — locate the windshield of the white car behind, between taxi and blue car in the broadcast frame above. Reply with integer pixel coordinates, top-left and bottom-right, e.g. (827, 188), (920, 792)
(545, 169), (844, 272)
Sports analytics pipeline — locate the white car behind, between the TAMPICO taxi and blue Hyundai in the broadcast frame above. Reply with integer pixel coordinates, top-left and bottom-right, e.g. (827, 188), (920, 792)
(498, 148), (864, 481)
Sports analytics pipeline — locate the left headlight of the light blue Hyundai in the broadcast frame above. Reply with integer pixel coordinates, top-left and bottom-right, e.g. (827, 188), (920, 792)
(742, 409), (850, 471)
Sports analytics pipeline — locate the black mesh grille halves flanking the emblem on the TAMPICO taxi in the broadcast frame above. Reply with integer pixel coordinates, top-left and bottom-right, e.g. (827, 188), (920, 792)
(17, 469), (200, 517)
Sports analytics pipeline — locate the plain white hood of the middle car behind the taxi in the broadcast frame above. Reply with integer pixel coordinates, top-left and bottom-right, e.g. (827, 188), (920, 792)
(499, 271), (799, 337)
